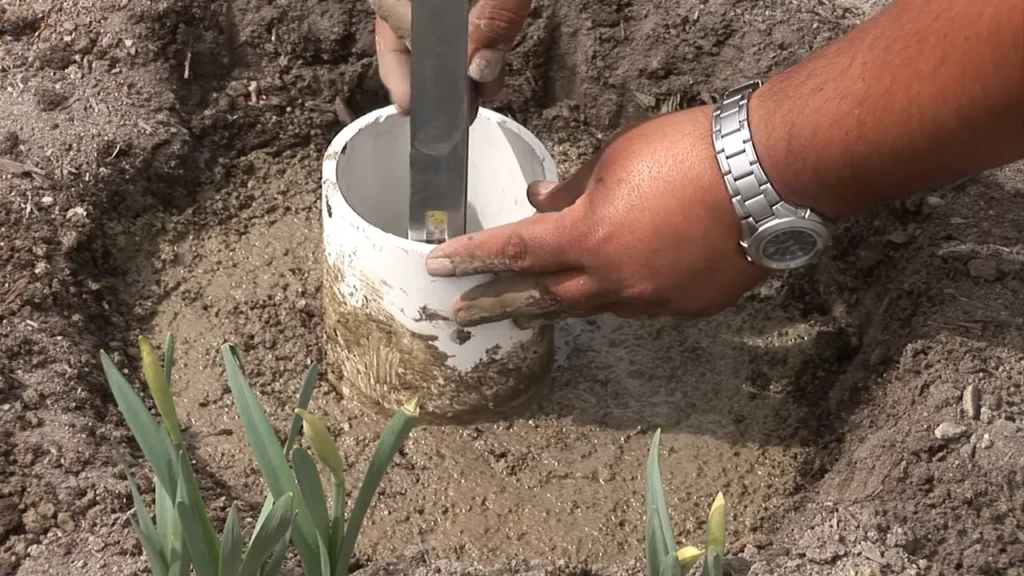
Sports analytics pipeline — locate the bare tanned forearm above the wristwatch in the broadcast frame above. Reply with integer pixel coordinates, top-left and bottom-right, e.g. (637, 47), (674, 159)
(750, 0), (1024, 217)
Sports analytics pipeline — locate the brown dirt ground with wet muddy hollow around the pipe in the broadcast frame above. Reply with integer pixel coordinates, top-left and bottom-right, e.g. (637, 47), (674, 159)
(0, 0), (1024, 576)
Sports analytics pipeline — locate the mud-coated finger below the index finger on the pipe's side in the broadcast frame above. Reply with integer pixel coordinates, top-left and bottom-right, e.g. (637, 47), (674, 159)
(454, 271), (601, 328)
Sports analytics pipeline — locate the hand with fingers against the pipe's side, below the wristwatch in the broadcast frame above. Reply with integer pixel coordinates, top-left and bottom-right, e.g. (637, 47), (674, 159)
(427, 107), (767, 327)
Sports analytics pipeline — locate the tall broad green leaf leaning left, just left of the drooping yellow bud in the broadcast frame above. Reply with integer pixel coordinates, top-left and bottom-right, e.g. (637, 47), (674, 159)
(222, 344), (322, 576)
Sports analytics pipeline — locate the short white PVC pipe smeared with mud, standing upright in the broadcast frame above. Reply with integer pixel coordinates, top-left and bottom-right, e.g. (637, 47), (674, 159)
(323, 107), (558, 420)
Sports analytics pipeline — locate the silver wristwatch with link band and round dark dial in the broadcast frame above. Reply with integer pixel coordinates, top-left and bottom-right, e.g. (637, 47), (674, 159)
(713, 80), (831, 271)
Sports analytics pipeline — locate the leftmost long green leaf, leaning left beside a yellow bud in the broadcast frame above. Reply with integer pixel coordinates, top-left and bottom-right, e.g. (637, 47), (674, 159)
(99, 352), (177, 491)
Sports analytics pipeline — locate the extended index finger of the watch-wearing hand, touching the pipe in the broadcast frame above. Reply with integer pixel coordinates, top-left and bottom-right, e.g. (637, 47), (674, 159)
(427, 212), (582, 278)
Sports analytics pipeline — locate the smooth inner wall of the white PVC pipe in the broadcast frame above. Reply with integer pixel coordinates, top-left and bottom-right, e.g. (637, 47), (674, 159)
(338, 116), (545, 238)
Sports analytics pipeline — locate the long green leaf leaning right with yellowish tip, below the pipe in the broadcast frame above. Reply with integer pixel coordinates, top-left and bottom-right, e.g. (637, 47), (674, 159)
(334, 398), (420, 576)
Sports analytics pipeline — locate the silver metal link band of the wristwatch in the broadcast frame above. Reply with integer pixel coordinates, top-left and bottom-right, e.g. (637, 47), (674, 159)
(712, 80), (799, 241)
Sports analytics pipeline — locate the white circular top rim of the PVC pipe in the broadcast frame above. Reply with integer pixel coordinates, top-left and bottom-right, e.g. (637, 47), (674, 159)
(323, 105), (558, 256)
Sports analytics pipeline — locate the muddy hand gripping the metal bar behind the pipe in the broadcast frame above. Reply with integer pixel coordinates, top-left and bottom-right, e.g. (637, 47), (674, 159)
(370, 0), (531, 112)
